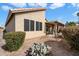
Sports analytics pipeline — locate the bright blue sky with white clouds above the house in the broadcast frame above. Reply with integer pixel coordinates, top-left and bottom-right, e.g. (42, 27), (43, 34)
(0, 3), (79, 26)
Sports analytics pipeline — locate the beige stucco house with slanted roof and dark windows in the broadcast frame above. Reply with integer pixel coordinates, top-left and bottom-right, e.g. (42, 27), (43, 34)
(5, 8), (62, 39)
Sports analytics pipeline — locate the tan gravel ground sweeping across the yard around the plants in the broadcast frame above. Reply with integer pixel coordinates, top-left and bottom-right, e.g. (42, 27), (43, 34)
(0, 36), (79, 56)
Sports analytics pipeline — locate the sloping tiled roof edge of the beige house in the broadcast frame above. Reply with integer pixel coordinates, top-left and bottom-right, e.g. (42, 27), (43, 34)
(5, 8), (46, 26)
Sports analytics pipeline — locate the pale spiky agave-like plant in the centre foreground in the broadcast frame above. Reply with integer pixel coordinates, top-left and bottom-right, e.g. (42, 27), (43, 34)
(27, 43), (50, 56)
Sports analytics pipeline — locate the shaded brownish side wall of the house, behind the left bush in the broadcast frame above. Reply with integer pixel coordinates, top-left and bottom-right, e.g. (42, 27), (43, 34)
(5, 16), (15, 32)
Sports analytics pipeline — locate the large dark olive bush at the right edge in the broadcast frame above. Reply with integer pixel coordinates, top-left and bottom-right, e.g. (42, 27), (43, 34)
(62, 26), (79, 50)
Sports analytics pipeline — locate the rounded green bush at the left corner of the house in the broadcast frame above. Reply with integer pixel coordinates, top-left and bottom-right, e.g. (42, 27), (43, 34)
(4, 32), (25, 51)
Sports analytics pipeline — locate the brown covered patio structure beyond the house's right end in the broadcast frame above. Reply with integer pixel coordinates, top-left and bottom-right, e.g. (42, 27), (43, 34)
(46, 21), (64, 34)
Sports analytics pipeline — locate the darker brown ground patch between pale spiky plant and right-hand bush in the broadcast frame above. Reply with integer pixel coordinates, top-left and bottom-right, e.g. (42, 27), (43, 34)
(46, 40), (72, 56)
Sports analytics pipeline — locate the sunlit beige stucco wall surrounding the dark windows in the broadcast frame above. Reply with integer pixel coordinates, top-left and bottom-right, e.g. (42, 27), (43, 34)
(15, 11), (46, 39)
